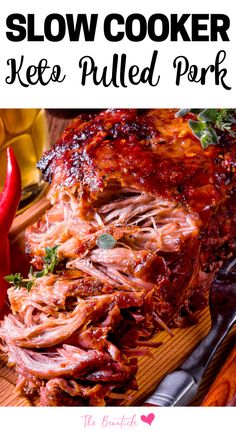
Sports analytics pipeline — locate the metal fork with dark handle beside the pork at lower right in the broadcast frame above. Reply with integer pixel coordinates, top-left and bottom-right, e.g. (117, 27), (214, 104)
(144, 257), (236, 406)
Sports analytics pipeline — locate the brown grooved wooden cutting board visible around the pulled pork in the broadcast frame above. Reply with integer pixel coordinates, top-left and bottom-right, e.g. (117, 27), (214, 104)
(0, 198), (235, 406)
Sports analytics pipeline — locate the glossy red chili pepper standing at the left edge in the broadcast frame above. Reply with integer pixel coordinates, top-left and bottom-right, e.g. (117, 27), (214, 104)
(0, 148), (21, 310)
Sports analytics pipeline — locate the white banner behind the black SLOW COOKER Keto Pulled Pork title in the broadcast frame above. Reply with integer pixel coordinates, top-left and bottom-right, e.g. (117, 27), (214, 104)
(0, 0), (236, 108)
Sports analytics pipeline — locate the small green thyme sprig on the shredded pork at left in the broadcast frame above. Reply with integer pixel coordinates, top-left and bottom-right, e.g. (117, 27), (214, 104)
(5, 245), (59, 292)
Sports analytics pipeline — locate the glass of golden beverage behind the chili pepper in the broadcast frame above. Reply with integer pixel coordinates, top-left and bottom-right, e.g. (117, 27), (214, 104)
(0, 109), (48, 207)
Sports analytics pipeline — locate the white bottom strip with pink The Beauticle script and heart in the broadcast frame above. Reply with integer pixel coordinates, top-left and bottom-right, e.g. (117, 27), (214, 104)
(0, 407), (235, 433)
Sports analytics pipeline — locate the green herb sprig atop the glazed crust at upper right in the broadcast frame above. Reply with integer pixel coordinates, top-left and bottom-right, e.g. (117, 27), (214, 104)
(176, 108), (236, 149)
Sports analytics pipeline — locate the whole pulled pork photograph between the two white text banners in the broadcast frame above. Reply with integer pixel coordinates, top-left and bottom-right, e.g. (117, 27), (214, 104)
(0, 108), (236, 407)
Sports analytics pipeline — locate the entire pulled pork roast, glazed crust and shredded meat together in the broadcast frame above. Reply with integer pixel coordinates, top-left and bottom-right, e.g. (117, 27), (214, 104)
(0, 110), (236, 406)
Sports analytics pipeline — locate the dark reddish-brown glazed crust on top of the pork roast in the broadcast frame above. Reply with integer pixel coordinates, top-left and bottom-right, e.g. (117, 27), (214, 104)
(38, 110), (236, 222)
